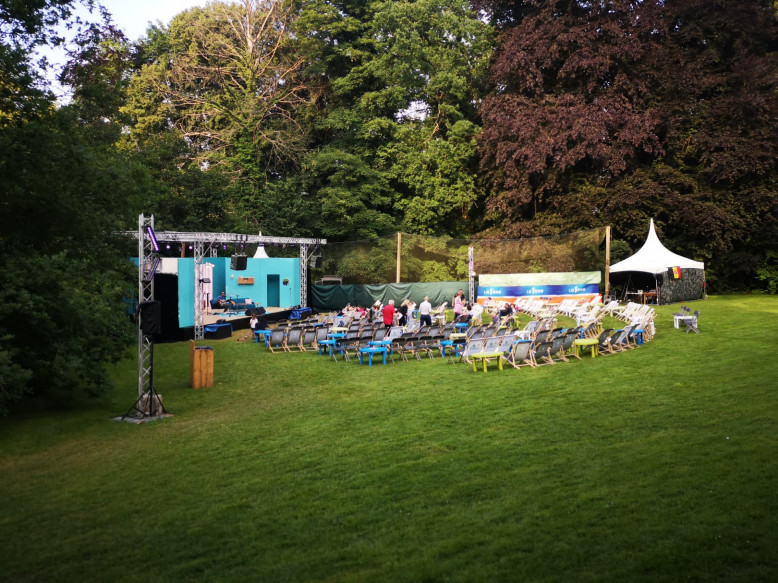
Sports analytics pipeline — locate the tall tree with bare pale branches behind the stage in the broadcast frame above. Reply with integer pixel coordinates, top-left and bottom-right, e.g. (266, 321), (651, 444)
(123, 0), (315, 233)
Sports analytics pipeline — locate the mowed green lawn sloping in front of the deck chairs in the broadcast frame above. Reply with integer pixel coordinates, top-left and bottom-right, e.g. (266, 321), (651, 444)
(0, 296), (778, 582)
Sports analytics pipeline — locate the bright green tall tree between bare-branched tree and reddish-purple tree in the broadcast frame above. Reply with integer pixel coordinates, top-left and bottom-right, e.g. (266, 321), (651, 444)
(298, 0), (491, 238)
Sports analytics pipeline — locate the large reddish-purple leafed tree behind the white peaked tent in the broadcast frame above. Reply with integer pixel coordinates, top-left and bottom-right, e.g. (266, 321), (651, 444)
(478, 0), (778, 290)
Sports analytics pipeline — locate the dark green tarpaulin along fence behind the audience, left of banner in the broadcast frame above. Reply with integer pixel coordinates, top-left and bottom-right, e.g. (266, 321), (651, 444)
(311, 281), (469, 312)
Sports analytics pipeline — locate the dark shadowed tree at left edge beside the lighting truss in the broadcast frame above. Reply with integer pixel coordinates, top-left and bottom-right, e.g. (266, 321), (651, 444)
(0, 2), (145, 412)
